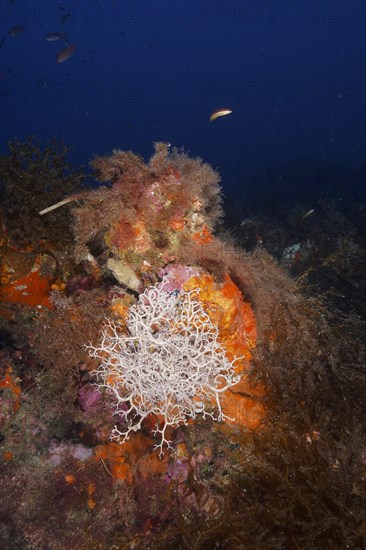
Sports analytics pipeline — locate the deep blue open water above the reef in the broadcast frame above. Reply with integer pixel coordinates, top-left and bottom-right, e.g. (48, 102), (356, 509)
(0, 0), (366, 200)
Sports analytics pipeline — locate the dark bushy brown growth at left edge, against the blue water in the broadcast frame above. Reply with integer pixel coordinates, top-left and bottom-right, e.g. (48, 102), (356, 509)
(0, 136), (85, 247)
